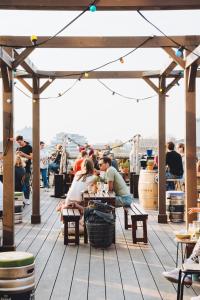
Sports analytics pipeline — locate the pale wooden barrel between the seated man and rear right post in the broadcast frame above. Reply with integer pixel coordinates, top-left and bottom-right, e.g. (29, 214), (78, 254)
(138, 170), (158, 210)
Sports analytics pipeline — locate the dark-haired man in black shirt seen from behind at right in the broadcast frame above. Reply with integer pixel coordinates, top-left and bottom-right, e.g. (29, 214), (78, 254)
(166, 142), (183, 190)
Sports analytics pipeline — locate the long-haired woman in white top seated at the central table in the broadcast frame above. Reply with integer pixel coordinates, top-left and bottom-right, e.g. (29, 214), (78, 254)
(57, 158), (97, 212)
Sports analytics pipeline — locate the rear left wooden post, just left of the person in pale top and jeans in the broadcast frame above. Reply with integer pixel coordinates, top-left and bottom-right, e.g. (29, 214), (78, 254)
(31, 76), (41, 224)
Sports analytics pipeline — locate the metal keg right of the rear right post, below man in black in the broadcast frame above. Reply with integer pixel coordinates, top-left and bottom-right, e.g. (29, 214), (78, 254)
(166, 191), (185, 223)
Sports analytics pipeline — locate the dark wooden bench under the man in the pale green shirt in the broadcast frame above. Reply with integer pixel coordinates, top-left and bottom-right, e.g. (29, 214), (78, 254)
(124, 203), (148, 244)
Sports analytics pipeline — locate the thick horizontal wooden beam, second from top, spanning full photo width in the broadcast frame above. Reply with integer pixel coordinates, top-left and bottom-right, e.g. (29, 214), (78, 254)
(0, 35), (200, 48)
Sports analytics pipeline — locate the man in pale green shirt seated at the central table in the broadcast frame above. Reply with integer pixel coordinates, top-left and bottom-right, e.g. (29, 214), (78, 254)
(99, 156), (133, 207)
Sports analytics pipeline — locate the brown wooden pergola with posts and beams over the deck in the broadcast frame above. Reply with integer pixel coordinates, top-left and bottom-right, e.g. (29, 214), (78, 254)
(0, 0), (200, 250)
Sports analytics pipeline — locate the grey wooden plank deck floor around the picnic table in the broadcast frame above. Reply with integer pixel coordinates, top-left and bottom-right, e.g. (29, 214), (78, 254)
(16, 192), (200, 300)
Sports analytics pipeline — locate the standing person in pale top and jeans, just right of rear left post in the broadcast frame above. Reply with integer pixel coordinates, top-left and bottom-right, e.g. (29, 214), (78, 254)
(40, 142), (49, 191)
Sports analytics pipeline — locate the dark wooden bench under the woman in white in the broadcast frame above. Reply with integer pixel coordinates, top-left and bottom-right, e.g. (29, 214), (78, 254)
(62, 208), (81, 245)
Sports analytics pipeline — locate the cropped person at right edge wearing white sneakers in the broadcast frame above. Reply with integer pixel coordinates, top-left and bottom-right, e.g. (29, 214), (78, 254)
(163, 207), (200, 300)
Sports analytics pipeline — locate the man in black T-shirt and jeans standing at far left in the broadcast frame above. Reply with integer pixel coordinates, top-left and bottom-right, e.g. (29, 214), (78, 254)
(16, 135), (33, 204)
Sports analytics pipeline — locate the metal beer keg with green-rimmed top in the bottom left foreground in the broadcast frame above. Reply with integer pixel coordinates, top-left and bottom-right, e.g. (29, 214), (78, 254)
(0, 252), (35, 300)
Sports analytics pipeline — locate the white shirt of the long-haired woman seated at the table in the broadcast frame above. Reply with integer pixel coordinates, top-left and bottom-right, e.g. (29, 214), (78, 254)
(65, 171), (96, 204)
